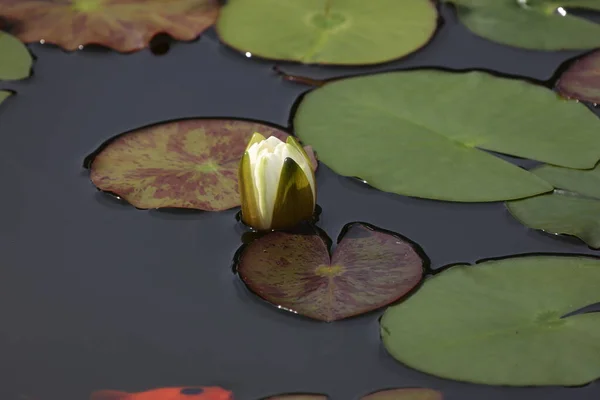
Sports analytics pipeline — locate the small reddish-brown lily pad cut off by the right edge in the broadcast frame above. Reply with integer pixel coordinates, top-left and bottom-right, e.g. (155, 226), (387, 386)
(556, 50), (600, 103)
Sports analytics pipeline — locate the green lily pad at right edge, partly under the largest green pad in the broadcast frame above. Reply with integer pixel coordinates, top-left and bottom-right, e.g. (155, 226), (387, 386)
(506, 165), (600, 249)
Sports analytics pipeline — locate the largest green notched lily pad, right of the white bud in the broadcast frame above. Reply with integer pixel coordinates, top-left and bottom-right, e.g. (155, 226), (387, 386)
(294, 70), (600, 202)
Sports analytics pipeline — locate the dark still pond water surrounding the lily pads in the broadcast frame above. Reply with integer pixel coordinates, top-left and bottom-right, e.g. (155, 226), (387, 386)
(0, 3), (600, 400)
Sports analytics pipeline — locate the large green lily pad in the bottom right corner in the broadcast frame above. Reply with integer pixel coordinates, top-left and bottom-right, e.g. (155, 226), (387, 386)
(381, 256), (600, 386)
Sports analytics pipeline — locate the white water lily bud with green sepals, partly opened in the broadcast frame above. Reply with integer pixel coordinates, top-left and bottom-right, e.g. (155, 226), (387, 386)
(239, 133), (317, 230)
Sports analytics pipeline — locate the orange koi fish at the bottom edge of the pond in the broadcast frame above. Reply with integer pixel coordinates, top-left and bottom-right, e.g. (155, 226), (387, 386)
(90, 386), (233, 400)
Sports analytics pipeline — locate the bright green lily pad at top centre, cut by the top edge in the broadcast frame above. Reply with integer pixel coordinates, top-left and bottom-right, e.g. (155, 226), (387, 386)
(216, 0), (437, 65)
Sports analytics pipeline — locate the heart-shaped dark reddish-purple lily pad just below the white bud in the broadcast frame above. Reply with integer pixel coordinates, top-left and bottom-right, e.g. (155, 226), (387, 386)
(238, 223), (424, 322)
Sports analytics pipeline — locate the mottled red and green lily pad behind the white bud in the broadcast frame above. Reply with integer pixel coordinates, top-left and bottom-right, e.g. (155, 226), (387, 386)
(88, 119), (317, 211)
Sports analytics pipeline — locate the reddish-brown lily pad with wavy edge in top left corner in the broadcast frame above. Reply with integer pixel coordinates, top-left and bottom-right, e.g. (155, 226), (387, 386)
(0, 0), (219, 52)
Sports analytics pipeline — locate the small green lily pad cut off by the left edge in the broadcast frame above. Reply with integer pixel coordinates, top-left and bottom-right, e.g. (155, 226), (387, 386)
(0, 30), (33, 80)
